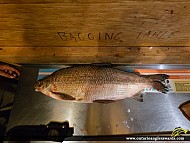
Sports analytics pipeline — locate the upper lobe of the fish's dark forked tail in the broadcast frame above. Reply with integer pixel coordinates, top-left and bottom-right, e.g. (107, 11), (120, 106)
(145, 74), (170, 82)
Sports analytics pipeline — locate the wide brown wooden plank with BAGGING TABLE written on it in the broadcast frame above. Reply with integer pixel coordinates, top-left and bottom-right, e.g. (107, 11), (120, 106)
(0, 0), (190, 47)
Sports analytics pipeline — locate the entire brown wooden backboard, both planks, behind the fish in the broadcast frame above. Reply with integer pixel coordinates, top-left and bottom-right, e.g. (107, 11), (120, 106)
(0, 0), (190, 64)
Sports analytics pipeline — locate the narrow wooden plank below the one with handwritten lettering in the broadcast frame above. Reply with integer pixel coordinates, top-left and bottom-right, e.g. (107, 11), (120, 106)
(0, 47), (190, 64)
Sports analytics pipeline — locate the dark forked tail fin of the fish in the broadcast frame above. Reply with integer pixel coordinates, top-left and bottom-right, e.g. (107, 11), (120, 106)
(145, 74), (169, 93)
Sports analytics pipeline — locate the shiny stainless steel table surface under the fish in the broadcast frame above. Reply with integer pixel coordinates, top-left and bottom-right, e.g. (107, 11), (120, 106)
(7, 65), (190, 135)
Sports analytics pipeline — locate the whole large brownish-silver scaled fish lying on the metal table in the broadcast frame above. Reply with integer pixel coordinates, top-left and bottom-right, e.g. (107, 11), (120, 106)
(34, 65), (169, 103)
